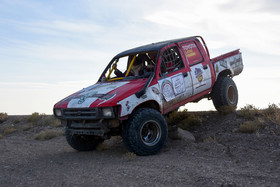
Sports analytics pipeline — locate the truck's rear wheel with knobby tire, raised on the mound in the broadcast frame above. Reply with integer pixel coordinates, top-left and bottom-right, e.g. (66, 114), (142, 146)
(211, 77), (238, 111)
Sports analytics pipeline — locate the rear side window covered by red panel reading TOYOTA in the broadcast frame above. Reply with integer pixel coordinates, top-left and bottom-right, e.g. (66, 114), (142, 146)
(181, 42), (203, 65)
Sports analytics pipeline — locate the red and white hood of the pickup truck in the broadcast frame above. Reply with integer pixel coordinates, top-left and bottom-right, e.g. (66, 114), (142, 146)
(54, 79), (146, 108)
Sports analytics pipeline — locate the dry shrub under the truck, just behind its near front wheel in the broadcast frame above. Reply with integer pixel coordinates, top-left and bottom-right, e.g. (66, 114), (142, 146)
(165, 109), (201, 130)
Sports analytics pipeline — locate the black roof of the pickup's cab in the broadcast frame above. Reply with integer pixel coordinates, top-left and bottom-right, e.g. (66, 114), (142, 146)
(115, 37), (195, 57)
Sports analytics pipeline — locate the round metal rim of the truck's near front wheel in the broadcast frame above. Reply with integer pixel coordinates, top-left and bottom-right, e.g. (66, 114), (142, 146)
(140, 120), (161, 146)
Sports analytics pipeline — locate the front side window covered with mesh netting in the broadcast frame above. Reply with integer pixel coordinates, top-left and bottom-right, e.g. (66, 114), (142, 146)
(160, 46), (184, 75)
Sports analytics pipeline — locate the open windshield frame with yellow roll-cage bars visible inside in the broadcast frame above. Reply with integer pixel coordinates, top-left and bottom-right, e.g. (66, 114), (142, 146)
(101, 52), (157, 81)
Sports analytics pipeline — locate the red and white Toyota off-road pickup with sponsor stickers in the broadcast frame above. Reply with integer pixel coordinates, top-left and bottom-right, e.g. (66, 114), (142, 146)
(53, 36), (243, 155)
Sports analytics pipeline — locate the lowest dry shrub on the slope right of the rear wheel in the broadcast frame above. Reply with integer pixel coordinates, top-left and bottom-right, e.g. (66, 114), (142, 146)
(237, 118), (265, 133)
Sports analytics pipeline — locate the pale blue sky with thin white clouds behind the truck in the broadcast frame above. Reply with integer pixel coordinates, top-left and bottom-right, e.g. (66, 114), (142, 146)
(0, 0), (280, 115)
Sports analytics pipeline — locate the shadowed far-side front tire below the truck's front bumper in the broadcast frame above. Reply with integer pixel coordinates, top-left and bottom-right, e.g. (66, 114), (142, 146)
(65, 128), (104, 151)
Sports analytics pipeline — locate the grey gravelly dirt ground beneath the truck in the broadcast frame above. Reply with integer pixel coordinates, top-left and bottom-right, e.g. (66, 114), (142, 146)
(0, 112), (280, 186)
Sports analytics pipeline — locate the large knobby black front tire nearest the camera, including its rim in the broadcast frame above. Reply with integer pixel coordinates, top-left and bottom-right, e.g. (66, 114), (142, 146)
(122, 108), (168, 156)
